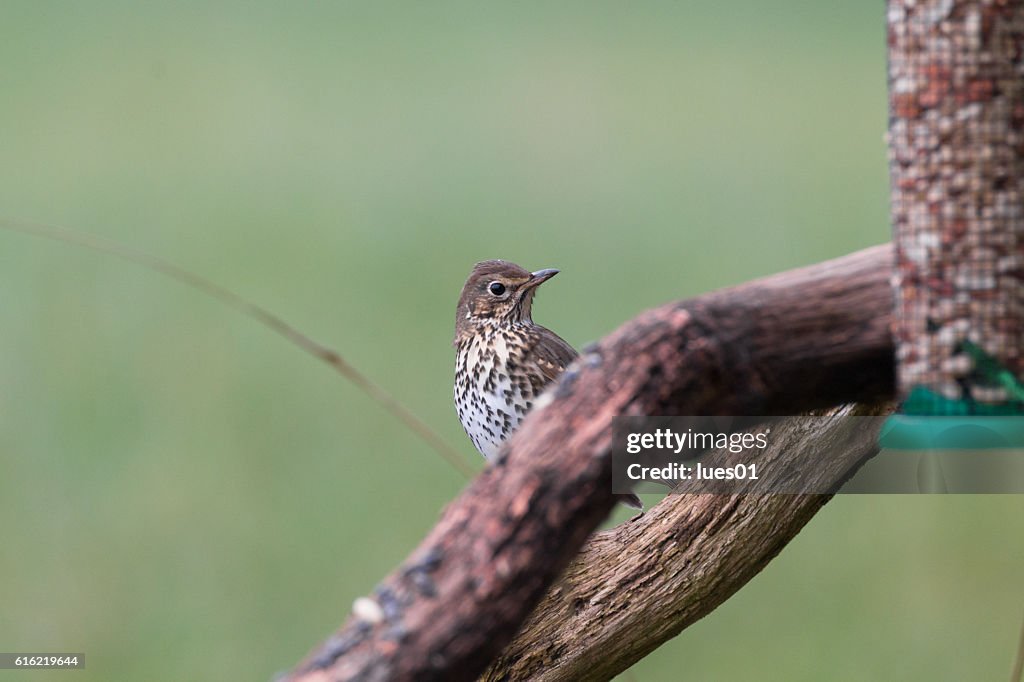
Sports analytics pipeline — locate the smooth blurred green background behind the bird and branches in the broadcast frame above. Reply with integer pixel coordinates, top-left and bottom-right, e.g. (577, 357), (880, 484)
(0, 0), (1024, 682)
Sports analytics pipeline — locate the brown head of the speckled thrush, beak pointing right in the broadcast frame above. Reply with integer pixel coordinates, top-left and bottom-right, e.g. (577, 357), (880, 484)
(455, 260), (558, 345)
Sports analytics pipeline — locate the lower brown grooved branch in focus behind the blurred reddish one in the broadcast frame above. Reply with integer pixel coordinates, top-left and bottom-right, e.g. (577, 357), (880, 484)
(481, 404), (892, 682)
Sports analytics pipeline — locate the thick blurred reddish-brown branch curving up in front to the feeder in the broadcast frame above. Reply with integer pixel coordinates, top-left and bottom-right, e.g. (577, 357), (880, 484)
(289, 241), (893, 680)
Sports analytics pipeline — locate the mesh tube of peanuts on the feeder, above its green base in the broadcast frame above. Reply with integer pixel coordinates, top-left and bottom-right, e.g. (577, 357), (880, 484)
(888, 0), (1024, 403)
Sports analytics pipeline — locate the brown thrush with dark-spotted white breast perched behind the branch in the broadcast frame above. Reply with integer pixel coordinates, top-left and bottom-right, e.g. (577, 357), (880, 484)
(453, 260), (643, 509)
